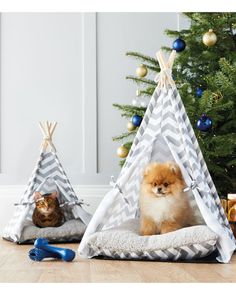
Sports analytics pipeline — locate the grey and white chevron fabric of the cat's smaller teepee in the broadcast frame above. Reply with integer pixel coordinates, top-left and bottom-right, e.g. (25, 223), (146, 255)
(3, 151), (91, 242)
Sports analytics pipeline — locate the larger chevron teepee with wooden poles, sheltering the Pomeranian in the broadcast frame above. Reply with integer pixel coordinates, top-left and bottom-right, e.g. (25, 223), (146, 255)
(78, 51), (236, 263)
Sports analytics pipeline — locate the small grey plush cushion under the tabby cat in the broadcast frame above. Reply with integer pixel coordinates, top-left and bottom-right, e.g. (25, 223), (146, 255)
(20, 219), (86, 243)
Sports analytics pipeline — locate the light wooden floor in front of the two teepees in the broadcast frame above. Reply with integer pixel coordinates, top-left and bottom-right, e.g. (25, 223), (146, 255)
(0, 240), (236, 283)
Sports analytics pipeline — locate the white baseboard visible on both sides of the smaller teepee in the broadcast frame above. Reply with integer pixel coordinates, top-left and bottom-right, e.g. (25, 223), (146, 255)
(0, 185), (111, 232)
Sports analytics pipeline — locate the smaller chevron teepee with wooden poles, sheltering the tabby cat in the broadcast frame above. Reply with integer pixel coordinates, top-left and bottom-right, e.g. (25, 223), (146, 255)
(3, 122), (91, 243)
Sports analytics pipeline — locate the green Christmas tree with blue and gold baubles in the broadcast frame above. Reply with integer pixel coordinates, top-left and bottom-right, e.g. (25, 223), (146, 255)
(113, 13), (236, 196)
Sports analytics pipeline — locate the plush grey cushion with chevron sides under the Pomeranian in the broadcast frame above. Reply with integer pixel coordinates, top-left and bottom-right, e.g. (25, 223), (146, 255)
(85, 219), (218, 260)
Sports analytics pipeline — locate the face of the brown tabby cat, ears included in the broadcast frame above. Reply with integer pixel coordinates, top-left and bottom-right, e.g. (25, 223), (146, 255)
(34, 192), (59, 214)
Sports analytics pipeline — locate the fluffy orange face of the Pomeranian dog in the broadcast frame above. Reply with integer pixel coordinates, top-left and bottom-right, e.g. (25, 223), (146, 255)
(142, 162), (184, 197)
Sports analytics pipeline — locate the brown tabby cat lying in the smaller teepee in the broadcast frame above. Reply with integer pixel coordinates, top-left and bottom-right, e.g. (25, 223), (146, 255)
(32, 192), (64, 227)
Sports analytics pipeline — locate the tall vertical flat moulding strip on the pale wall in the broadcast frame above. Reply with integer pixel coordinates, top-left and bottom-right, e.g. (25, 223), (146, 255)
(82, 13), (98, 175)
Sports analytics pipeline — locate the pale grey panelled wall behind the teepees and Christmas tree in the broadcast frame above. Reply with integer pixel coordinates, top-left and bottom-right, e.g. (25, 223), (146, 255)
(0, 13), (187, 231)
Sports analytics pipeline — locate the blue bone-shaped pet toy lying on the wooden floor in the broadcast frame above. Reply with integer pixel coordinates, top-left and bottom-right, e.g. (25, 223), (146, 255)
(29, 238), (75, 262)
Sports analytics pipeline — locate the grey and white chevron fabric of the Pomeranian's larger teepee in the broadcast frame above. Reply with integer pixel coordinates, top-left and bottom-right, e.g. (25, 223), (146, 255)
(79, 86), (235, 262)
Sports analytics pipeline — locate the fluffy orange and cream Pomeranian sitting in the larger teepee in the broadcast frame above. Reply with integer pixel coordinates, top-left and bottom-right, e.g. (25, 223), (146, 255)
(139, 162), (196, 236)
